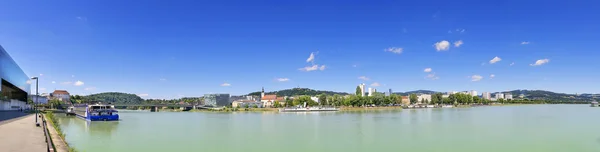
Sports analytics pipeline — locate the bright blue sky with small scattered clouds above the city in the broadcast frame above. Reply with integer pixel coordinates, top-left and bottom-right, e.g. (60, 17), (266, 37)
(0, 0), (600, 99)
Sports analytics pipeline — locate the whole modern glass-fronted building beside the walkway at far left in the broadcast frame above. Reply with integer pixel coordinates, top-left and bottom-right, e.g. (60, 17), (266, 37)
(0, 46), (31, 111)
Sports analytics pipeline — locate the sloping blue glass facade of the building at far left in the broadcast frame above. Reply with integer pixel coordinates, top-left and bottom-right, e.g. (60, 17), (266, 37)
(0, 46), (30, 101)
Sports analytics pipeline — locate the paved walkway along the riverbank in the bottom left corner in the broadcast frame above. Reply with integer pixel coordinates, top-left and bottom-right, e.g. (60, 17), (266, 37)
(0, 114), (47, 152)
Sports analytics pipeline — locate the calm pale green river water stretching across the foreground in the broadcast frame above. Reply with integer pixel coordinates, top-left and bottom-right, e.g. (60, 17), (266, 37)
(59, 105), (600, 152)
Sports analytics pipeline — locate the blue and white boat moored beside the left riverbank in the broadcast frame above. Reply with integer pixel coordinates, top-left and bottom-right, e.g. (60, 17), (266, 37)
(73, 104), (119, 121)
